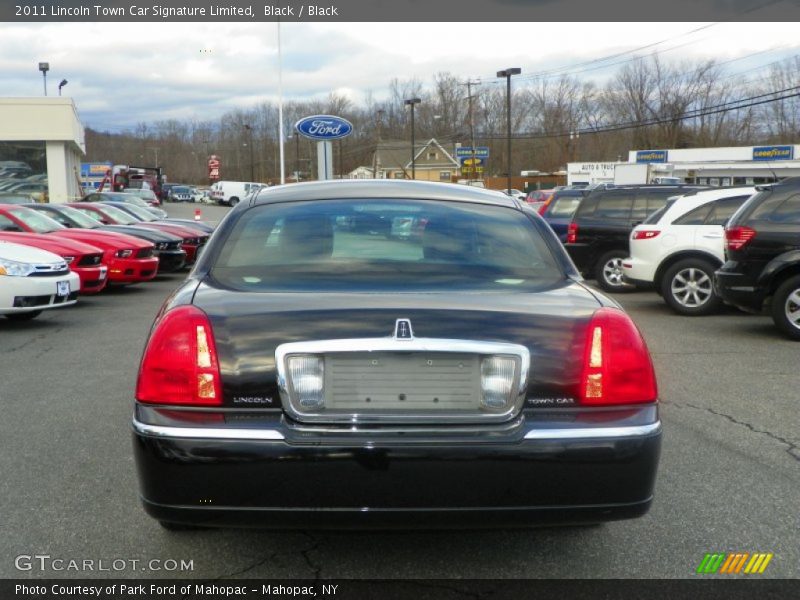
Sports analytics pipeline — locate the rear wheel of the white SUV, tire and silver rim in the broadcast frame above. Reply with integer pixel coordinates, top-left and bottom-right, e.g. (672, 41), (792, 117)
(661, 258), (722, 316)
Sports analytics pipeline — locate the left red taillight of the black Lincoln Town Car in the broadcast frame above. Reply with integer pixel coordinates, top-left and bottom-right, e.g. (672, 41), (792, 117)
(136, 306), (222, 406)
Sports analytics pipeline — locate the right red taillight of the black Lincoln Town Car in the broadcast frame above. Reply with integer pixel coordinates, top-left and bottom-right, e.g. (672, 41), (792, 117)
(580, 308), (658, 406)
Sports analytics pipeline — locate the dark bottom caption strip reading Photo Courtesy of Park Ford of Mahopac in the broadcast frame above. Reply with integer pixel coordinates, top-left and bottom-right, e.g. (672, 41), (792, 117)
(0, 576), (797, 600)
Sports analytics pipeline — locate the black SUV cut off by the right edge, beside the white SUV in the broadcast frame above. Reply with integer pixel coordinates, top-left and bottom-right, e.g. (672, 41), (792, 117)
(714, 177), (800, 340)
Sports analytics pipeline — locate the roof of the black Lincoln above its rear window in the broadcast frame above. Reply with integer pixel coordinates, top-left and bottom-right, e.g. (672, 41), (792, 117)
(251, 179), (519, 208)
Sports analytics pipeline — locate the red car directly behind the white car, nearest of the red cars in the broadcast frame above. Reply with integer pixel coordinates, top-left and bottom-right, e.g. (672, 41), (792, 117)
(0, 231), (108, 294)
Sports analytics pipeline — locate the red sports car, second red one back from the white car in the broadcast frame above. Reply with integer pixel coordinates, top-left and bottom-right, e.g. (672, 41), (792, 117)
(0, 205), (158, 283)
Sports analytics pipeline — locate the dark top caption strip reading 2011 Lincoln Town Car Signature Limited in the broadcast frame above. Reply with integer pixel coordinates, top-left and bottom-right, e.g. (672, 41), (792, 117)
(0, 0), (800, 21)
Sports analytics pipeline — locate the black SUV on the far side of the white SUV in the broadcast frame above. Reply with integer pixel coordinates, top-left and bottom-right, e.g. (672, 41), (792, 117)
(566, 185), (701, 292)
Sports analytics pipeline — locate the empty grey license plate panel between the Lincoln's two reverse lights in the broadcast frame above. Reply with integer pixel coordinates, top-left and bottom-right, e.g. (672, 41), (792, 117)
(324, 352), (481, 413)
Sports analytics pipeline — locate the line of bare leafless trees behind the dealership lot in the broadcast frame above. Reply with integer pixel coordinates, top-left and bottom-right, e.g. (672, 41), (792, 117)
(86, 55), (800, 184)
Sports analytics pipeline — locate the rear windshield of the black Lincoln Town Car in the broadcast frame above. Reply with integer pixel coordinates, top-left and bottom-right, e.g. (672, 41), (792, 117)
(211, 200), (564, 292)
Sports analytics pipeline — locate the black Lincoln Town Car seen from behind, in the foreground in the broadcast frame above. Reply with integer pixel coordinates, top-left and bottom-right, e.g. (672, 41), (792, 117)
(133, 180), (661, 529)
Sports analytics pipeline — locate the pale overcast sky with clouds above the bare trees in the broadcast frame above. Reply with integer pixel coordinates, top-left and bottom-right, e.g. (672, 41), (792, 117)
(0, 23), (800, 132)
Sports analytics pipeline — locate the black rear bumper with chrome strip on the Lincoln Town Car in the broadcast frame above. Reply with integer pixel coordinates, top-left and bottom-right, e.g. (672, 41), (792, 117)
(133, 405), (661, 528)
